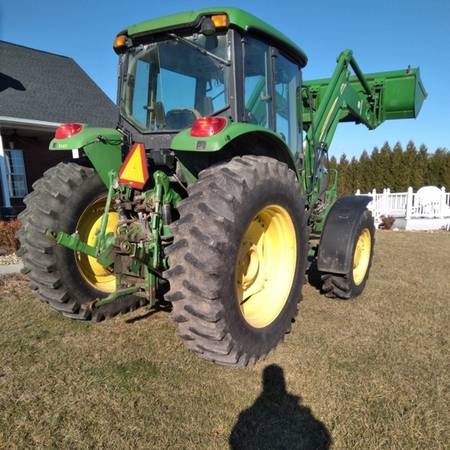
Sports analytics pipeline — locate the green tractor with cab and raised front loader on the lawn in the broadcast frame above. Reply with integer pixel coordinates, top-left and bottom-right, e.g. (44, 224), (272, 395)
(18, 8), (426, 366)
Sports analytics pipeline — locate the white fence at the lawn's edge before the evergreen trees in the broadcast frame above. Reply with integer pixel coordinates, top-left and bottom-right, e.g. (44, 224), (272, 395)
(356, 186), (450, 222)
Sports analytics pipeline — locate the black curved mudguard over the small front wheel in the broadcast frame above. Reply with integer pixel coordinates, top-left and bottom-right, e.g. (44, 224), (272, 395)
(317, 195), (372, 274)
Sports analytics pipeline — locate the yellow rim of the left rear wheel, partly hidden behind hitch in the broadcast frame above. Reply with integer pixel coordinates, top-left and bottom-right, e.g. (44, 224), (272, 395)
(75, 196), (119, 292)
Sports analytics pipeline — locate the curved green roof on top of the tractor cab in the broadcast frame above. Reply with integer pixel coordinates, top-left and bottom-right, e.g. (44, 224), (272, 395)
(119, 7), (308, 67)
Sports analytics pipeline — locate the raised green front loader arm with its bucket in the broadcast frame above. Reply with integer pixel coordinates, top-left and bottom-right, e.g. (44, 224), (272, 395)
(299, 50), (427, 231)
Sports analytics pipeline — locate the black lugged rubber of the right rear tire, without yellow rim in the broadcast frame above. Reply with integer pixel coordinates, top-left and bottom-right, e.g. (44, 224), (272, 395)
(164, 156), (307, 366)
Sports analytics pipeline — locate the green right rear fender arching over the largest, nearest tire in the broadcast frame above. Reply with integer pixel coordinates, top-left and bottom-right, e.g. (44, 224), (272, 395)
(170, 121), (298, 173)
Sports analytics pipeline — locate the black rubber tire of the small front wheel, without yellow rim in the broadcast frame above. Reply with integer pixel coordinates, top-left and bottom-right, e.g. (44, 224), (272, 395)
(321, 209), (375, 300)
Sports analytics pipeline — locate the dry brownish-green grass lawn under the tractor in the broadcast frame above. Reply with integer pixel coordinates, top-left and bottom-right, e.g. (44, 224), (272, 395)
(0, 232), (450, 450)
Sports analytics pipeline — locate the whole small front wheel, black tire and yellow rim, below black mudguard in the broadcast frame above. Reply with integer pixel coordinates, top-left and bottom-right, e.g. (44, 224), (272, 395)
(321, 209), (375, 300)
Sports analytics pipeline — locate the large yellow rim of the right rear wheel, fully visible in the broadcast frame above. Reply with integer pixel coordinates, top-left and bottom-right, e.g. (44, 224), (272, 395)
(236, 205), (297, 328)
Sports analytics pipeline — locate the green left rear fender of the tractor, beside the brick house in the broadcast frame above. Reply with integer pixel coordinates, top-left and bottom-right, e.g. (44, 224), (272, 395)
(49, 124), (124, 187)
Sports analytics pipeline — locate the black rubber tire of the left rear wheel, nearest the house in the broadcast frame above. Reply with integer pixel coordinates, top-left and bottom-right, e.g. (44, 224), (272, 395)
(17, 163), (145, 321)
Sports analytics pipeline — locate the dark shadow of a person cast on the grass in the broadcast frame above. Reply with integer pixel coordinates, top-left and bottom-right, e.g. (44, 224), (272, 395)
(229, 364), (331, 450)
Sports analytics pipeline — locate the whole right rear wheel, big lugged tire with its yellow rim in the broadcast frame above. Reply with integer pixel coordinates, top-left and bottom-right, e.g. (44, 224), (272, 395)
(164, 156), (307, 366)
